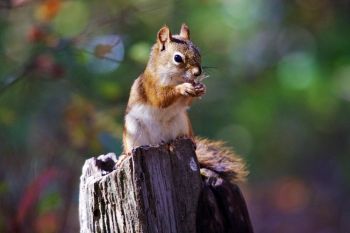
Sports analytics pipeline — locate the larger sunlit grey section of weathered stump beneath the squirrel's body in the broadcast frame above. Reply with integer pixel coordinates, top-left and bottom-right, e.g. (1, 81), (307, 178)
(79, 139), (202, 233)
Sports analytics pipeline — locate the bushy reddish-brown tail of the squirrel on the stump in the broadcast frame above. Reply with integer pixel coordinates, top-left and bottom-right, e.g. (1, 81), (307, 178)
(195, 137), (248, 182)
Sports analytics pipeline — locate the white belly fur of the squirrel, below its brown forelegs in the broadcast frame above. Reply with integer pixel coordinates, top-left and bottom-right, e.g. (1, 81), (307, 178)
(125, 103), (189, 148)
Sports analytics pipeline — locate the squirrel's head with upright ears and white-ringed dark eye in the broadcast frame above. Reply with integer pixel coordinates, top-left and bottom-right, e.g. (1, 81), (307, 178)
(148, 24), (202, 85)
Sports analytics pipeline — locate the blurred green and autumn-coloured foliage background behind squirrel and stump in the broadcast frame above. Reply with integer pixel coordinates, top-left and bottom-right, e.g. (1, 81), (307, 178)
(0, 0), (350, 233)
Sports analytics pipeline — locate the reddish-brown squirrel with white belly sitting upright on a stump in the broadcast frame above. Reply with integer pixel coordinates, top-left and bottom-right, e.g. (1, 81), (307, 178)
(123, 24), (247, 182)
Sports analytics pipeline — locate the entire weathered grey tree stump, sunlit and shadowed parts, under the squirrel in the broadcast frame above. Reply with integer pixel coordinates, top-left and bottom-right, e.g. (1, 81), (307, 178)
(79, 139), (253, 233)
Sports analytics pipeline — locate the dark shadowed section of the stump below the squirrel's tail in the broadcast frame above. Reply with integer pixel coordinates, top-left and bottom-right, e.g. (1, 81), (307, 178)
(197, 168), (253, 233)
